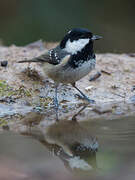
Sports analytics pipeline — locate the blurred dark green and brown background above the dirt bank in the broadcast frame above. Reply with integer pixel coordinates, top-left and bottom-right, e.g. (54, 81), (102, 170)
(0, 0), (135, 53)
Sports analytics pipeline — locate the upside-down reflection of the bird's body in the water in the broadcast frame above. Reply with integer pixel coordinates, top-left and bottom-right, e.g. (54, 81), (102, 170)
(22, 109), (98, 173)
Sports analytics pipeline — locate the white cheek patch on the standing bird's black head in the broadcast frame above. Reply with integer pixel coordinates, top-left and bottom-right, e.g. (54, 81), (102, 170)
(64, 39), (89, 54)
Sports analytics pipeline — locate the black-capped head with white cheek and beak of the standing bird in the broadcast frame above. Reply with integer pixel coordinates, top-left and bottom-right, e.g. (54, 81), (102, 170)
(60, 28), (101, 54)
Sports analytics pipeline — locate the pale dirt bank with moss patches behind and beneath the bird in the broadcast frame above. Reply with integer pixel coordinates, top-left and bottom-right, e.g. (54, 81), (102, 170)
(0, 41), (135, 131)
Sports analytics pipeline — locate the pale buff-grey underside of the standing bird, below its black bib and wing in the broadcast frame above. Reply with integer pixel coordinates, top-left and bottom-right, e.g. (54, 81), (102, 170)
(44, 59), (96, 84)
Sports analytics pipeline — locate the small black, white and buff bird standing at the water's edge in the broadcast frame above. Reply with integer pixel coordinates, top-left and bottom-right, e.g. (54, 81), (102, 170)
(18, 28), (102, 116)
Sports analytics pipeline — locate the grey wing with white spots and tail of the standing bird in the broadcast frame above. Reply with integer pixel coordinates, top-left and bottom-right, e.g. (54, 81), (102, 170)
(18, 46), (69, 65)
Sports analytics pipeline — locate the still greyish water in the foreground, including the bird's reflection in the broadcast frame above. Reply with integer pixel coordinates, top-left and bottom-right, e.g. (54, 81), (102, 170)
(0, 114), (135, 180)
